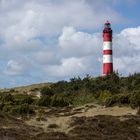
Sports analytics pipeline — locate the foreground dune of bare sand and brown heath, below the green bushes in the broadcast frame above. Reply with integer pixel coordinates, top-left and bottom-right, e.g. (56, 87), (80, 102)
(0, 104), (140, 140)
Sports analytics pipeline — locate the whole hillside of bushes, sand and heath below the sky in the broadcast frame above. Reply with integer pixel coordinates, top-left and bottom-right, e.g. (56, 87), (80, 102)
(0, 73), (140, 140)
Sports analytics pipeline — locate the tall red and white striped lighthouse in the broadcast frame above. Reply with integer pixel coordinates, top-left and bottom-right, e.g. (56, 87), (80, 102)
(103, 21), (113, 76)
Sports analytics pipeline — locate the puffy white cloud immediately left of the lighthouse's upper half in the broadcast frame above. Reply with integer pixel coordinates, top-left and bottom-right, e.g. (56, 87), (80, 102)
(59, 27), (102, 57)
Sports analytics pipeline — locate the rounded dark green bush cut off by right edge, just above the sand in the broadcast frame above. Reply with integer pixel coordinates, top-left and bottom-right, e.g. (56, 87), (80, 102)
(130, 91), (140, 108)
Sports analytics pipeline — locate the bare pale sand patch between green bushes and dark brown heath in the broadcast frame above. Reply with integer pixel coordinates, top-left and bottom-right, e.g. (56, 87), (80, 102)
(26, 104), (137, 133)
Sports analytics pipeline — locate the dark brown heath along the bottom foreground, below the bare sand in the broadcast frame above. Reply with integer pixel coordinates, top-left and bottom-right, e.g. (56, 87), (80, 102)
(0, 114), (140, 140)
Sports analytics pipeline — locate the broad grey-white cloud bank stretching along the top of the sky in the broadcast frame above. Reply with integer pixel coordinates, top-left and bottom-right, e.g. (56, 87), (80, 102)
(0, 0), (122, 38)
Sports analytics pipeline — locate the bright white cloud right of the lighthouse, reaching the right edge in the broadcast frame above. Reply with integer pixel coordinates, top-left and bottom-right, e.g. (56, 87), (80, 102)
(113, 27), (140, 75)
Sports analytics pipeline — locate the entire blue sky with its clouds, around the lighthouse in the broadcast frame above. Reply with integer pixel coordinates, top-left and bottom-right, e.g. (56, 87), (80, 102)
(0, 0), (140, 88)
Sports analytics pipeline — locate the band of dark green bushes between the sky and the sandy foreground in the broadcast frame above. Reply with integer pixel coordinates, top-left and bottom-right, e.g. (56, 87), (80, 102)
(0, 73), (140, 115)
